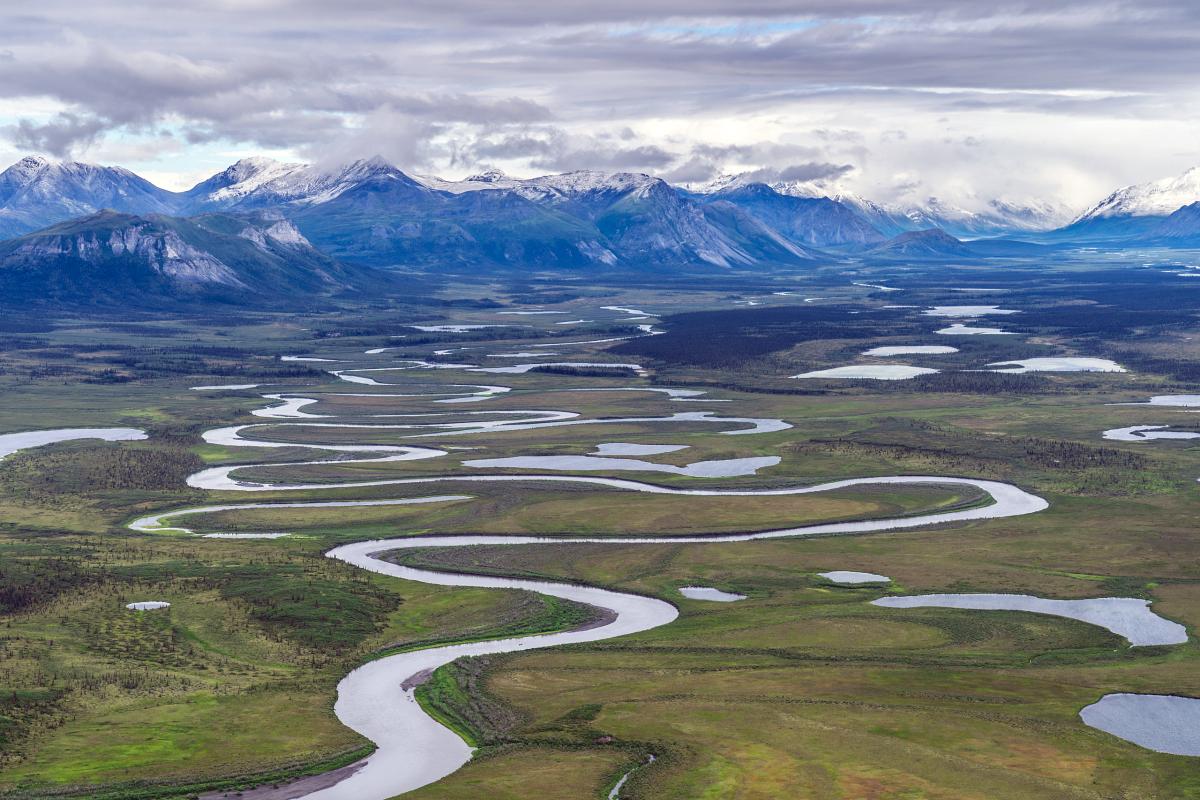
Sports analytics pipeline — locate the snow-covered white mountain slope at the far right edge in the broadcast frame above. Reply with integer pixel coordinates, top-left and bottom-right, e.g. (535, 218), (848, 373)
(1057, 167), (1200, 239)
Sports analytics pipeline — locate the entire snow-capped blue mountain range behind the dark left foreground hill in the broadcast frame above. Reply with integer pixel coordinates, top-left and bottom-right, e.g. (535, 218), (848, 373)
(0, 156), (1200, 270)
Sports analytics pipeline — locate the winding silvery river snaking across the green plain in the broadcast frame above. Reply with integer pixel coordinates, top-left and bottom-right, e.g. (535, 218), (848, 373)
(130, 375), (1048, 800)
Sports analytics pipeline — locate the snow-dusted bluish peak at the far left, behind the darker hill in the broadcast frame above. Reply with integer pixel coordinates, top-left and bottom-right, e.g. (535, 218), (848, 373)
(0, 156), (178, 239)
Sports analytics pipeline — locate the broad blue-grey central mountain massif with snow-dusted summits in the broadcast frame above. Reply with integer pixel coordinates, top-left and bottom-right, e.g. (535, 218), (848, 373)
(286, 162), (820, 269)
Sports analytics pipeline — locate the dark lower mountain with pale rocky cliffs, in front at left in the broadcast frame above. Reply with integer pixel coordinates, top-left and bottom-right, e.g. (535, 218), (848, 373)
(0, 210), (391, 307)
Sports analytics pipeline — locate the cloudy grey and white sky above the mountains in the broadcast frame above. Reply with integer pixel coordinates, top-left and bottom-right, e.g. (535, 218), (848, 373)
(0, 0), (1200, 210)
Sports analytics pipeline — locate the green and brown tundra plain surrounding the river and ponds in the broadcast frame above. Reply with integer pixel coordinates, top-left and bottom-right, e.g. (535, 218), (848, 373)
(0, 265), (1200, 800)
